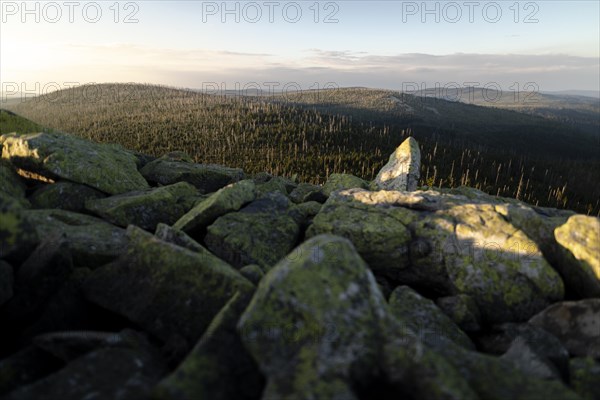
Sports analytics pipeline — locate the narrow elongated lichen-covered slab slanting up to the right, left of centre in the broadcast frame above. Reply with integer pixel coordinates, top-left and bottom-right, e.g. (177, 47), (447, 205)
(173, 180), (256, 233)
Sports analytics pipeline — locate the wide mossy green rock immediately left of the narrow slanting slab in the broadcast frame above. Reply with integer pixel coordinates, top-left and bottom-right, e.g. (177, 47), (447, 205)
(85, 182), (198, 231)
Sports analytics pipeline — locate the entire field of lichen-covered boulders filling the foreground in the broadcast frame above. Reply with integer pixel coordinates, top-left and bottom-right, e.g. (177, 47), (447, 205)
(0, 133), (600, 400)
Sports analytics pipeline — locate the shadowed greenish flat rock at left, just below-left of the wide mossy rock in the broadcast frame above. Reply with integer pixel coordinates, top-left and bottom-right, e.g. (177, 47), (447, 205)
(24, 210), (127, 268)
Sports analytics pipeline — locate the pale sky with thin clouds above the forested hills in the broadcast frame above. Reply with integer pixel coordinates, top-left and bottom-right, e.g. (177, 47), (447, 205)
(0, 0), (600, 94)
